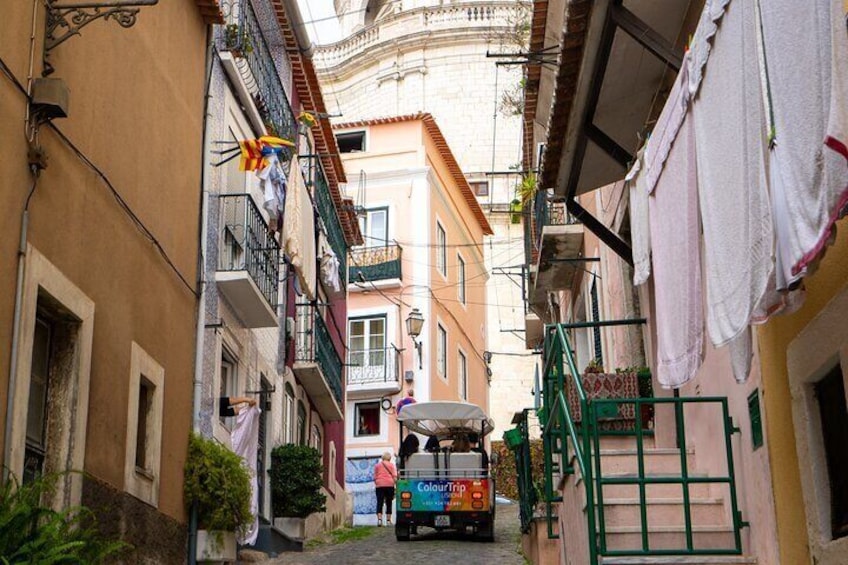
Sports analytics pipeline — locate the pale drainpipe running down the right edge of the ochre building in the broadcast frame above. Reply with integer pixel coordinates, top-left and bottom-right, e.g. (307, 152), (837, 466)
(188, 20), (215, 565)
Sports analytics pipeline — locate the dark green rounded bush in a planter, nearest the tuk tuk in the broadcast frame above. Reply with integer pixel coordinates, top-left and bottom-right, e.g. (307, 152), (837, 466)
(268, 444), (327, 518)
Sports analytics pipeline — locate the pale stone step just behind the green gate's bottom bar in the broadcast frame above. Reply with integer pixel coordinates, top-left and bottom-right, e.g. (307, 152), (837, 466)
(606, 525), (735, 551)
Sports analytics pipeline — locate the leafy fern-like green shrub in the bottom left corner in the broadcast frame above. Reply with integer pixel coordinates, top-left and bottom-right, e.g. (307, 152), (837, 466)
(0, 473), (130, 564)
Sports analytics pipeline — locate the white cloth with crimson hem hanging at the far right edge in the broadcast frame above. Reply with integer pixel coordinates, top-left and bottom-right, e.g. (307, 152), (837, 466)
(760, 0), (848, 290)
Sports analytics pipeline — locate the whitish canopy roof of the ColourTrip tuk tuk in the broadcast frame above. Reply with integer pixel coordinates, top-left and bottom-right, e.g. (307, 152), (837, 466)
(398, 401), (495, 437)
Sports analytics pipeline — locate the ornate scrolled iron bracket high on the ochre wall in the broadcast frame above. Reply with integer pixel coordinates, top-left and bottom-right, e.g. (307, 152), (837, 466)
(42, 0), (159, 76)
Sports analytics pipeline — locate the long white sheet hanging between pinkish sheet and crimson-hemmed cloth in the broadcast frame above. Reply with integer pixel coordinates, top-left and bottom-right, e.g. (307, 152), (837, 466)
(692, 2), (773, 380)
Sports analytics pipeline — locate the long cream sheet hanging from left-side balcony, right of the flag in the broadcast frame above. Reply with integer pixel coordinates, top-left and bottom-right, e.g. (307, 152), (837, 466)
(283, 156), (317, 300)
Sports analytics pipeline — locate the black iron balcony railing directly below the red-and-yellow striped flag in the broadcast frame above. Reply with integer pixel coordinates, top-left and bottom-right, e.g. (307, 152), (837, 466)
(218, 194), (280, 308)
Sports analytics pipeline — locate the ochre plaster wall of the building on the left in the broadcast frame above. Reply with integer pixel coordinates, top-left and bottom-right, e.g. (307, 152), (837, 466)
(0, 0), (207, 520)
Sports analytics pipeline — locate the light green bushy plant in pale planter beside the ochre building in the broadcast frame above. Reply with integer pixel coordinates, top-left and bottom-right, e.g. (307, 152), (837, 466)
(183, 434), (253, 561)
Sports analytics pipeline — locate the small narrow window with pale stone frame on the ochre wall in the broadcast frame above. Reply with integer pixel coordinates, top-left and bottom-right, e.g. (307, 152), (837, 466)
(124, 342), (165, 506)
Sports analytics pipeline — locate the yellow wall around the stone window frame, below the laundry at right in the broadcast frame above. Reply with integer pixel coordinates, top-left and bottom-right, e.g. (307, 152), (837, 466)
(758, 226), (848, 565)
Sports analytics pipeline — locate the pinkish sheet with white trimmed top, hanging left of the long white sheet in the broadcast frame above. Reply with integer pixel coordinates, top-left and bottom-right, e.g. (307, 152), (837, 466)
(646, 58), (705, 388)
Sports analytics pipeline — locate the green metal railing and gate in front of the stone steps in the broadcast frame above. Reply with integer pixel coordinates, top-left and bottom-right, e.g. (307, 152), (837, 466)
(539, 320), (747, 564)
